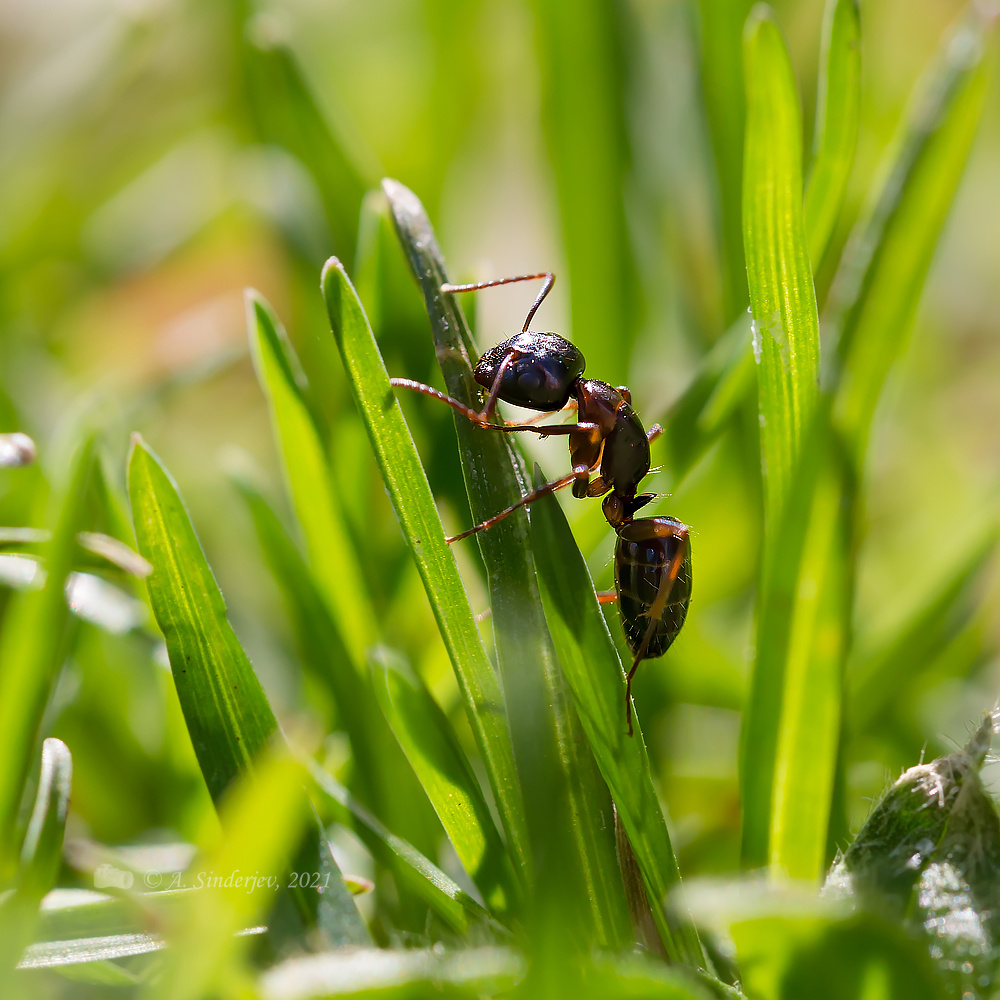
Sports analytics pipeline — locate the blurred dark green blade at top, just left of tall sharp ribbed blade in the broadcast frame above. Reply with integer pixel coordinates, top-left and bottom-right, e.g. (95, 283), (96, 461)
(698, 0), (750, 323)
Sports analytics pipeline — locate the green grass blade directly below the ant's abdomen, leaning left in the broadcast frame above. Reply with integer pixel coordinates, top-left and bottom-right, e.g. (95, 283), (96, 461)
(531, 480), (705, 967)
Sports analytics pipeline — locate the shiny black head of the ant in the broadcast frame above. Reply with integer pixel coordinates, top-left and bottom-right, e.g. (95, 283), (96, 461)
(475, 331), (586, 410)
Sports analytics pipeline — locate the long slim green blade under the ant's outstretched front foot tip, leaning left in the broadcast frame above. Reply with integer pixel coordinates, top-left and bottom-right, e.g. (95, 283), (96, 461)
(322, 254), (528, 880)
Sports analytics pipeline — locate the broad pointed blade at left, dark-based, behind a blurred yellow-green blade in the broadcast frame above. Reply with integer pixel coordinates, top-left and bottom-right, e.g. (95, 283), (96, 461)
(128, 435), (367, 941)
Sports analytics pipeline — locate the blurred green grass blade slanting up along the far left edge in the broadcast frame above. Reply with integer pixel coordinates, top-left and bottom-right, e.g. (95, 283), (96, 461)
(0, 436), (94, 872)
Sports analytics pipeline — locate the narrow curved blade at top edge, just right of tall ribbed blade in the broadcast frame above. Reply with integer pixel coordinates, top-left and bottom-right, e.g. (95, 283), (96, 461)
(806, 0), (861, 269)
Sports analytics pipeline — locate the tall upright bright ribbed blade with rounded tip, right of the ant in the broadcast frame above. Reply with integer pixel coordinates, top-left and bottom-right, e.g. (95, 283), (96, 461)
(743, 4), (819, 528)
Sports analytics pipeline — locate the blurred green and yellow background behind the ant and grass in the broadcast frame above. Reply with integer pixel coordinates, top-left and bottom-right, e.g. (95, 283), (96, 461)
(0, 0), (1000, 874)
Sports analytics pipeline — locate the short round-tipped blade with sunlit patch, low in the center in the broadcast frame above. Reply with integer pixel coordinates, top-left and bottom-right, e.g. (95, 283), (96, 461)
(372, 651), (520, 917)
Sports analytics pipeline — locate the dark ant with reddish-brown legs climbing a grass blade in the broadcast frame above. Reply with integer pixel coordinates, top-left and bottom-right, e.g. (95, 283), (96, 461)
(390, 271), (691, 736)
